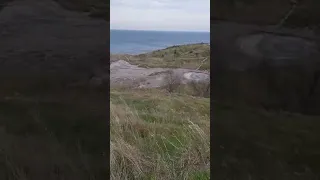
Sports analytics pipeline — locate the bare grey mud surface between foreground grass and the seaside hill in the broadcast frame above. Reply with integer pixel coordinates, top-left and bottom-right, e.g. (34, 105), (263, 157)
(110, 60), (210, 88)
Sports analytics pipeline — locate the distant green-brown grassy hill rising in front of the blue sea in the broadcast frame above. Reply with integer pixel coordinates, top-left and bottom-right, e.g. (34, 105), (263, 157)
(110, 43), (210, 70)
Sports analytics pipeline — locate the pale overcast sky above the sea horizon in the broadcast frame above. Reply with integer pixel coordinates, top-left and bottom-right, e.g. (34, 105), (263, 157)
(110, 0), (210, 31)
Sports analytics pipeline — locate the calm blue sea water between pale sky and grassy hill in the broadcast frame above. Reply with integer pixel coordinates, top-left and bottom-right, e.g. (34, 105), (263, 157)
(110, 30), (210, 54)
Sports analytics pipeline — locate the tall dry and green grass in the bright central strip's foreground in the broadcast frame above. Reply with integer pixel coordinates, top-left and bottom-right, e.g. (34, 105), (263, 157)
(110, 90), (210, 180)
